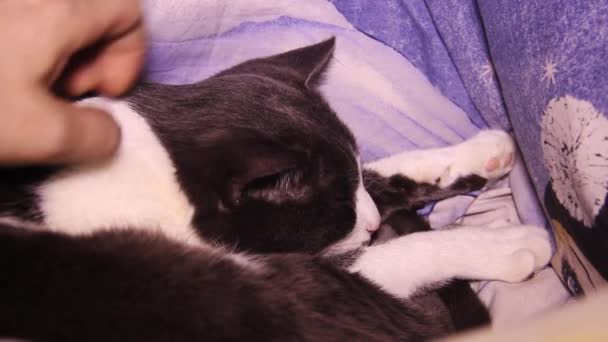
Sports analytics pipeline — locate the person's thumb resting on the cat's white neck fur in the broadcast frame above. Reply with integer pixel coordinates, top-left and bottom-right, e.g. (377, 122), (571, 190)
(0, 95), (120, 165)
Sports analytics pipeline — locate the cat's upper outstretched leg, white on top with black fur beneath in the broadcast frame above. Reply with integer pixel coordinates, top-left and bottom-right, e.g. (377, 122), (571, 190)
(363, 130), (515, 217)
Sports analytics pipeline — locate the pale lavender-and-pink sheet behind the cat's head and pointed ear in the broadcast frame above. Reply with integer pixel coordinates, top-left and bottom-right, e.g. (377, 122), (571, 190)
(145, 0), (485, 161)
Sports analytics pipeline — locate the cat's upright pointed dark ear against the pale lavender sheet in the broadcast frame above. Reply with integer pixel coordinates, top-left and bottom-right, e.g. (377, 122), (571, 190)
(270, 37), (336, 88)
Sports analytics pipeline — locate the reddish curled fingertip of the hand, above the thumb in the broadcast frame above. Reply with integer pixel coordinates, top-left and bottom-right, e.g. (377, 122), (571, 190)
(62, 30), (145, 96)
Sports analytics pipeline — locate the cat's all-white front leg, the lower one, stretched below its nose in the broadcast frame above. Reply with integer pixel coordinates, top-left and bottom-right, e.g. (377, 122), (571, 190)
(349, 225), (552, 298)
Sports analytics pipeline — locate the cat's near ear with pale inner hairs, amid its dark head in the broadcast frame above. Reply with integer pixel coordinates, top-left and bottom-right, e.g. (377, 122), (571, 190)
(227, 147), (312, 206)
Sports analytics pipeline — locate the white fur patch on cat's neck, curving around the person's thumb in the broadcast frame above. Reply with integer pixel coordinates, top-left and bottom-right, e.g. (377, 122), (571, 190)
(38, 98), (197, 242)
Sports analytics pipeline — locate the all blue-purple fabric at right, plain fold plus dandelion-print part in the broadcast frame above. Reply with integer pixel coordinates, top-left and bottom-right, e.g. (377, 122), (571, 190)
(338, 0), (608, 294)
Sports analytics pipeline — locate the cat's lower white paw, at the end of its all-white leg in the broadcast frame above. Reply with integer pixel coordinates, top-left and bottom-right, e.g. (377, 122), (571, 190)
(479, 225), (552, 283)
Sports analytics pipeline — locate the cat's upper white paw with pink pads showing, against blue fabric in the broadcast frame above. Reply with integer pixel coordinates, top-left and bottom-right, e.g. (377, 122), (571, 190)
(446, 130), (515, 186)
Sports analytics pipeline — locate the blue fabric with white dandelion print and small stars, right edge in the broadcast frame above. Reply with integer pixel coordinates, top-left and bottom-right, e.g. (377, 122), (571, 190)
(479, 0), (608, 294)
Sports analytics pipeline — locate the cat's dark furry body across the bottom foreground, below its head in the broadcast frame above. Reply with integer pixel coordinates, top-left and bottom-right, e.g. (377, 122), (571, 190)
(0, 225), (450, 341)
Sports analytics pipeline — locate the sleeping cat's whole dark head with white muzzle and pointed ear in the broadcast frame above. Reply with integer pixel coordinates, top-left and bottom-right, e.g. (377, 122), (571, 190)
(131, 38), (380, 252)
